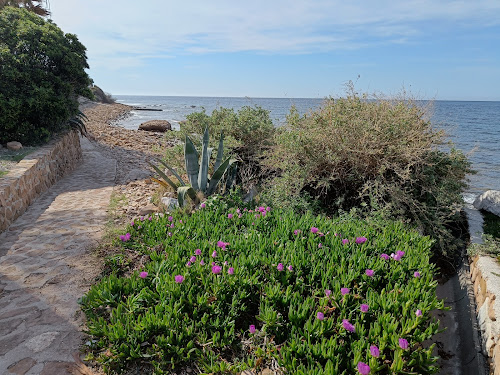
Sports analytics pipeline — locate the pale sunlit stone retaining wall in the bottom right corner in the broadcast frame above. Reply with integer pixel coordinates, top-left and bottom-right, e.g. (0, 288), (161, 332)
(470, 255), (500, 375)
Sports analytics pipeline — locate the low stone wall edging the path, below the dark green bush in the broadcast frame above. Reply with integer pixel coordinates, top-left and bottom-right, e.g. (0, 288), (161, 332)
(0, 131), (82, 232)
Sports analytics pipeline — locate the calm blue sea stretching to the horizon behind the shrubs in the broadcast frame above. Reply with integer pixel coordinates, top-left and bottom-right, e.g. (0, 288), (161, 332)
(116, 95), (500, 203)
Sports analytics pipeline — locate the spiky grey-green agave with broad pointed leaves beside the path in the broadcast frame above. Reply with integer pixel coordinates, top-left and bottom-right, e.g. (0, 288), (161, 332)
(149, 128), (236, 207)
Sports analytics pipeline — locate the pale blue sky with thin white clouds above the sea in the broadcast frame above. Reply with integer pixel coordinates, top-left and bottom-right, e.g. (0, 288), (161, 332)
(50, 0), (500, 100)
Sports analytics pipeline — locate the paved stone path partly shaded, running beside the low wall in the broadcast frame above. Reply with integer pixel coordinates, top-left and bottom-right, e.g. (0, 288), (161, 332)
(0, 139), (116, 375)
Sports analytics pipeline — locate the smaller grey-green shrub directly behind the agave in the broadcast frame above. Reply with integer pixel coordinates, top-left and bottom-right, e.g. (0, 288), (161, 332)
(165, 106), (275, 187)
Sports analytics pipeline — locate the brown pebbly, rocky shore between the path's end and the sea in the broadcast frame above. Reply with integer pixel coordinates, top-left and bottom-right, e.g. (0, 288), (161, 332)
(80, 102), (178, 221)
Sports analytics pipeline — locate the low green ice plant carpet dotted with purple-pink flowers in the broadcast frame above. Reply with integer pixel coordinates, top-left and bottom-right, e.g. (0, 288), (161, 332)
(81, 203), (443, 374)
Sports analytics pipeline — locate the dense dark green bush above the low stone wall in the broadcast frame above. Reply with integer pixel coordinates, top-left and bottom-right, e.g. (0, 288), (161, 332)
(0, 7), (91, 144)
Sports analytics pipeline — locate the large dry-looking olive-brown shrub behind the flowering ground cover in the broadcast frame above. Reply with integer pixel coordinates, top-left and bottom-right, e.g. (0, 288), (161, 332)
(265, 89), (471, 255)
